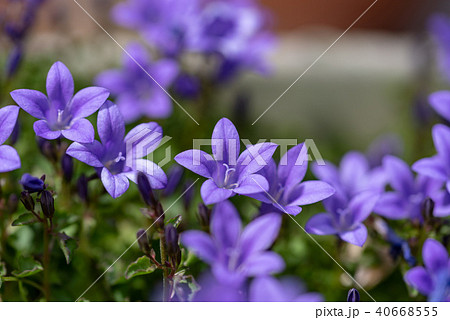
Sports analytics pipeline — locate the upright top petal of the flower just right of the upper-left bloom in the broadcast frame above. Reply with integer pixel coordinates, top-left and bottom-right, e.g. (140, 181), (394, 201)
(97, 101), (125, 145)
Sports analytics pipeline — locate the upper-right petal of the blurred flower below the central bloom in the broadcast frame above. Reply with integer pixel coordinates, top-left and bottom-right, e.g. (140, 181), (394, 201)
(240, 213), (281, 256)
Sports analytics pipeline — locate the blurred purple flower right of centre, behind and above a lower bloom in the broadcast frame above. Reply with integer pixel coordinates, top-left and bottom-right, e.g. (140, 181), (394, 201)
(312, 151), (386, 202)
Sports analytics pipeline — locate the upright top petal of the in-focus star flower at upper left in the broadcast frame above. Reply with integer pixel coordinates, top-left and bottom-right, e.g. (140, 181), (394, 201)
(47, 61), (74, 109)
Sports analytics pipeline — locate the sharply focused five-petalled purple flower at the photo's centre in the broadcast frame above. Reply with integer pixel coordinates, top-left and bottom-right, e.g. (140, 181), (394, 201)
(175, 118), (277, 204)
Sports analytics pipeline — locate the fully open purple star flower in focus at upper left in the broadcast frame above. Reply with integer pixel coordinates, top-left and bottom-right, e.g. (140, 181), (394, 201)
(11, 62), (109, 143)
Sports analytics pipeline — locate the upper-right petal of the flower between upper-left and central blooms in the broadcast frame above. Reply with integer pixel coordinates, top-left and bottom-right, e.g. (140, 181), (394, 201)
(125, 122), (163, 159)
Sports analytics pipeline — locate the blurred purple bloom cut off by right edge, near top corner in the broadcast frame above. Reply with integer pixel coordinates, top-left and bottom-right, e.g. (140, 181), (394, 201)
(430, 14), (450, 80)
